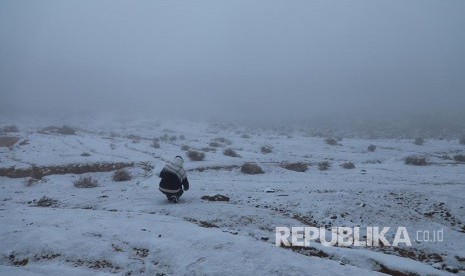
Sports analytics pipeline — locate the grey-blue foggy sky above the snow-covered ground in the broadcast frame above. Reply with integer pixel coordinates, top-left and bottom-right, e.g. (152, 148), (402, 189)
(0, 0), (465, 126)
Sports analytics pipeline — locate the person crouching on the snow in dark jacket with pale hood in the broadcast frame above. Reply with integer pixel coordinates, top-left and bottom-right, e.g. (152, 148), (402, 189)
(160, 156), (189, 203)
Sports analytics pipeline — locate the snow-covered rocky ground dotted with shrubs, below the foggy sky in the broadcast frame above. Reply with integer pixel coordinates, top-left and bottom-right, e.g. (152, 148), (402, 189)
(0, 117), (465, 275)
